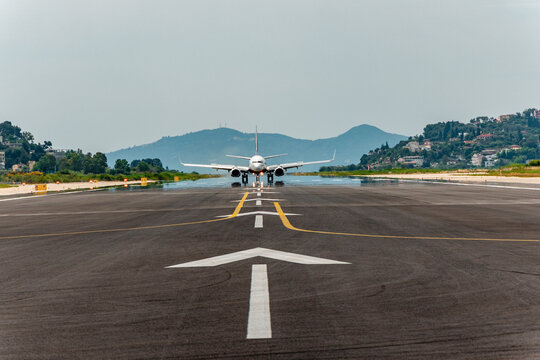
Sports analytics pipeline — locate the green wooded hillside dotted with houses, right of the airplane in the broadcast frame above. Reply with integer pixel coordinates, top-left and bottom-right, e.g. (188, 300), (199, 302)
(321, 109), (540, 171)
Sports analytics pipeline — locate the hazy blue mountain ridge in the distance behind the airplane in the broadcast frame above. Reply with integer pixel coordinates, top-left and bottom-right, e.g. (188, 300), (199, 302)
(106, 125), (407, 173)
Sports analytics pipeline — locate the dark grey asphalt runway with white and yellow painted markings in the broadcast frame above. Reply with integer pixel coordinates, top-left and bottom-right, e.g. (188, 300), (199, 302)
(0, 182), (540, 359)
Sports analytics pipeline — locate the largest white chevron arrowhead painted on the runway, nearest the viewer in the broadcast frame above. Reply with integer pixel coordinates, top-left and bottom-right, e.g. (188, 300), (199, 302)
(167, 247), (350, 268)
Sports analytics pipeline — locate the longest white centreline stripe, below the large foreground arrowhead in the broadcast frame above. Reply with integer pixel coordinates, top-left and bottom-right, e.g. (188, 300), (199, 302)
(246, 264), (272, 339)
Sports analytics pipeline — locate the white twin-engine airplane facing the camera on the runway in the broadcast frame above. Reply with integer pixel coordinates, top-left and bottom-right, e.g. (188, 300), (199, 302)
(182, 130), (336, 184)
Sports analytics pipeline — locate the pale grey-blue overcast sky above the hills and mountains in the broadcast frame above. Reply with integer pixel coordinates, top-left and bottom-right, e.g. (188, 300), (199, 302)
(0, 0), (540, 152)
